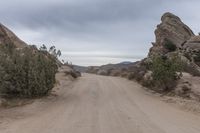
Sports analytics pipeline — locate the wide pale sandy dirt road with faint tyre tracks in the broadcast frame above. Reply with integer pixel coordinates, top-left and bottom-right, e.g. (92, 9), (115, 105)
(0, 74), (200, 133)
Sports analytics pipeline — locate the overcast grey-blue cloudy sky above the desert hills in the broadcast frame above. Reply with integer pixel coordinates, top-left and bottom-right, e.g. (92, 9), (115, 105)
(0, 0), (200, 66)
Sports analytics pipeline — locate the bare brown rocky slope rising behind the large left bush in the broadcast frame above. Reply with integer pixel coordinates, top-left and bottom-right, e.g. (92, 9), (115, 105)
(0, 24), (27, 48)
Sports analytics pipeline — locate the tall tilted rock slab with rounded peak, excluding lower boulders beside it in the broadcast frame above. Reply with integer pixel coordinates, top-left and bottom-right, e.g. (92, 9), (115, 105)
(149, 13), (194, 56)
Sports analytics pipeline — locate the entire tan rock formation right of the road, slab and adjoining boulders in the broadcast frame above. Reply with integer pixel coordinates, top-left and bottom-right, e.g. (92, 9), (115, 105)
(147, 13), (200, 76)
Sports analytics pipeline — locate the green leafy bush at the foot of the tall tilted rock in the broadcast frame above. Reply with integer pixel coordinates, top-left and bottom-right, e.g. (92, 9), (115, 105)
(151, 55), (182, 91)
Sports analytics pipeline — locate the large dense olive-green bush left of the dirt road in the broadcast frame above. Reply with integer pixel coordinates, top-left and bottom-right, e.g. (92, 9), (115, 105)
(0, 44), (57, 97)
